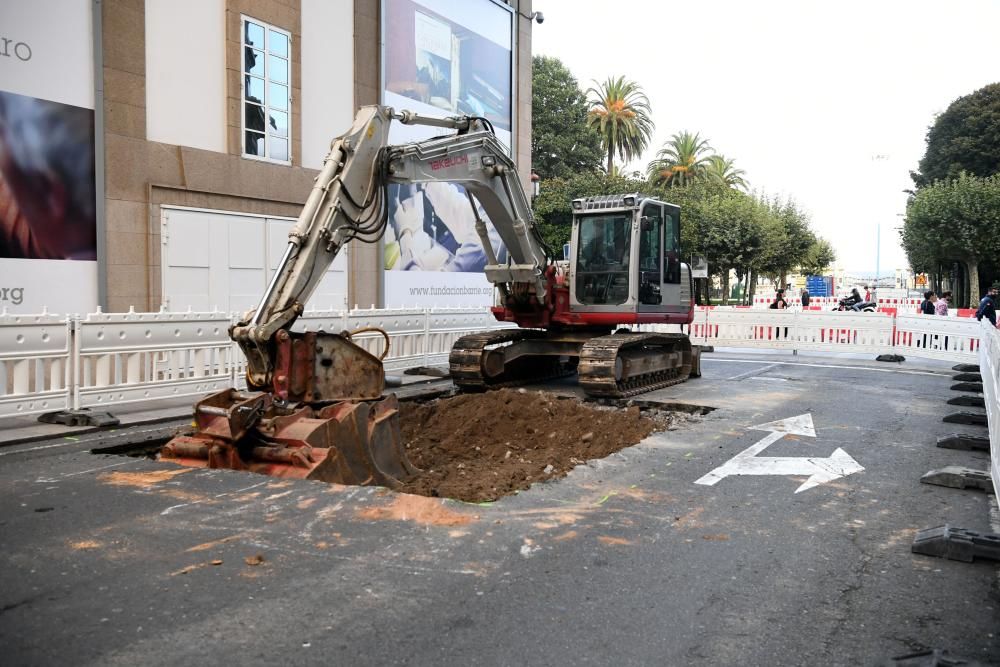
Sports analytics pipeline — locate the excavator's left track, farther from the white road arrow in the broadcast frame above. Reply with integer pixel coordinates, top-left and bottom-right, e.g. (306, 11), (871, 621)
(448, 329), (576, 391)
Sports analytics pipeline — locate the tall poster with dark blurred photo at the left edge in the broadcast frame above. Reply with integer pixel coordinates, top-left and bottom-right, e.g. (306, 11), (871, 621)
(0, 0), (98, 313)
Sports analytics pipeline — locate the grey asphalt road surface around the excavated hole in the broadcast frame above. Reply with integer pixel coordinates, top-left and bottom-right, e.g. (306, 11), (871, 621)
(0, 355), (1000, 665)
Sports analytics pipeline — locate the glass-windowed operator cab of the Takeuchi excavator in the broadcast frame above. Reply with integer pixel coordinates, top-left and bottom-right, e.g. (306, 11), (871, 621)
(570, 194), (692, 321)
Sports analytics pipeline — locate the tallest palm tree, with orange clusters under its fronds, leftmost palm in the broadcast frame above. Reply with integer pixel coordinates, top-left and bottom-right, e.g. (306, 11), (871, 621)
(587, 76), (653, 174)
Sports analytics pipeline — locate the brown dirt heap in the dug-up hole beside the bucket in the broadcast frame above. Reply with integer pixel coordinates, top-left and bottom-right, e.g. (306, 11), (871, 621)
(400, 389), (673, 502)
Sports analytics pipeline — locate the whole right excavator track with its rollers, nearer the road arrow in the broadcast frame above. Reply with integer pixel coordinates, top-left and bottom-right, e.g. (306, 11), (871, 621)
(579, 333), (700, 398)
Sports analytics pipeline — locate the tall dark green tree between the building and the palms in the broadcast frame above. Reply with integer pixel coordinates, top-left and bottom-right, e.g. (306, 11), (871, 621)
(531, 56), (604, 179)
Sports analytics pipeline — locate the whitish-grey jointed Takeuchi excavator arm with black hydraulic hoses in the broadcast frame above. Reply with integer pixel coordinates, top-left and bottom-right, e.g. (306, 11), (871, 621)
(230, 106), (548, 388)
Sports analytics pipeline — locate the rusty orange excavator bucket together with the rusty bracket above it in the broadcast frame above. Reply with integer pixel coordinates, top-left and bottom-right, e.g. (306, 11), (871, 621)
(160, 333), (419, 488)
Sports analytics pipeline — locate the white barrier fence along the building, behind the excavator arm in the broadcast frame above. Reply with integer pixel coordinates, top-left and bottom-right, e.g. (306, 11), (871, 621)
(0, 308), (512, 417)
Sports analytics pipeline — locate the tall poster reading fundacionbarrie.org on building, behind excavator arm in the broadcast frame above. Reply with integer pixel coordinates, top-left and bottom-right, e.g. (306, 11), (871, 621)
(382, 0), (514, 307)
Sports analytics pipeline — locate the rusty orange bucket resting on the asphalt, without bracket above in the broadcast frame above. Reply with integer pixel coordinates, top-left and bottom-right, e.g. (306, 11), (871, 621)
(160, 390), (419, 488)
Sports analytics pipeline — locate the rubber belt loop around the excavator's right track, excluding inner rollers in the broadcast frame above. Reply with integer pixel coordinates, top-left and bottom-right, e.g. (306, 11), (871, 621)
(579, 333), (693, 398)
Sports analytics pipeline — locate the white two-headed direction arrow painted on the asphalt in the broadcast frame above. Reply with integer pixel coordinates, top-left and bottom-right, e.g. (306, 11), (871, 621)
(695, 413), (864, 493)
